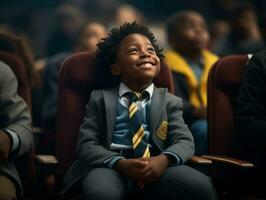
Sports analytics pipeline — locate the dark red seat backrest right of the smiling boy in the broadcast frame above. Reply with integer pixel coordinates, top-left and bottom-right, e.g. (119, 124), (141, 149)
(208, 55), (248, 156)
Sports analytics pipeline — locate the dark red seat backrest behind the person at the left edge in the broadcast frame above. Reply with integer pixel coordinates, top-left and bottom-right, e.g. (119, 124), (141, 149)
(0, 51), (35, 196)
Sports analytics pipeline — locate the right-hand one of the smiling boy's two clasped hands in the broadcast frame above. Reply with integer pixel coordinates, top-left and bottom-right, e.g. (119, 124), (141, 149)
(141, 154), (170, 184)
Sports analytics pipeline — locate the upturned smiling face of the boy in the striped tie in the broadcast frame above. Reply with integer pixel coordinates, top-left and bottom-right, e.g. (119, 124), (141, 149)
(111, 34), (160, 90)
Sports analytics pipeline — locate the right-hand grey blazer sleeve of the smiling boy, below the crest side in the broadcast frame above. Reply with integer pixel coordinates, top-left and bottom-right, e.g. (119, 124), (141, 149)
(165, 95), (195, 163)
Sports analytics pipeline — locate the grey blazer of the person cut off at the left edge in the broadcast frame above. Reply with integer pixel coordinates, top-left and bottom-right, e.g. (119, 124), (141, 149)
(0, 61), (33, 198)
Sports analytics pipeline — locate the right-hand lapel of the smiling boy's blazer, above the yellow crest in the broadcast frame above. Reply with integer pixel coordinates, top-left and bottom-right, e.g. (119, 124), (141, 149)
(150, 87), (164, 134)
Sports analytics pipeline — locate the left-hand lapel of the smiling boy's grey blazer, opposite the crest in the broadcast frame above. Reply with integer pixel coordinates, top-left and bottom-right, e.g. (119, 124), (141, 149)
(103, 88), (118, 147)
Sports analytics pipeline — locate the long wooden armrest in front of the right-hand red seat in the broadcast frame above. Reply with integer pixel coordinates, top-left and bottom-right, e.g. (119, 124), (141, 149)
(201, 155), (254, 168)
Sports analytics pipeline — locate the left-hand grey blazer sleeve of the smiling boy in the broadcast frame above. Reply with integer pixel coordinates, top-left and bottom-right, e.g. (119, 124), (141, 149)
(76, 91), (119, 168)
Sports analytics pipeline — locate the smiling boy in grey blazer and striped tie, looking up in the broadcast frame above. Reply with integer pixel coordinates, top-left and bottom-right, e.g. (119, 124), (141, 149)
(62, 22), (216, 199)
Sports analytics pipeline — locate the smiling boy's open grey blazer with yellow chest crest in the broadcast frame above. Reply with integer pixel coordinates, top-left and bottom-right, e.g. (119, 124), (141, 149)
(62, 87), (194, 194)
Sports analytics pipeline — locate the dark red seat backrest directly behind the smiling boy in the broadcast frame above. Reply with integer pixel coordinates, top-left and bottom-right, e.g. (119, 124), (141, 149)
(56, 52), (174, 186)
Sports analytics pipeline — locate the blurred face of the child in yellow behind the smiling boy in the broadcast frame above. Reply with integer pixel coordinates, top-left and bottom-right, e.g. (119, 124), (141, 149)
(174, 12), (209, 50)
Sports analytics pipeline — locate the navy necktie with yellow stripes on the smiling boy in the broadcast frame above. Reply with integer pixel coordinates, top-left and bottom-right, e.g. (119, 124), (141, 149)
(128, 91), (150, 158)
